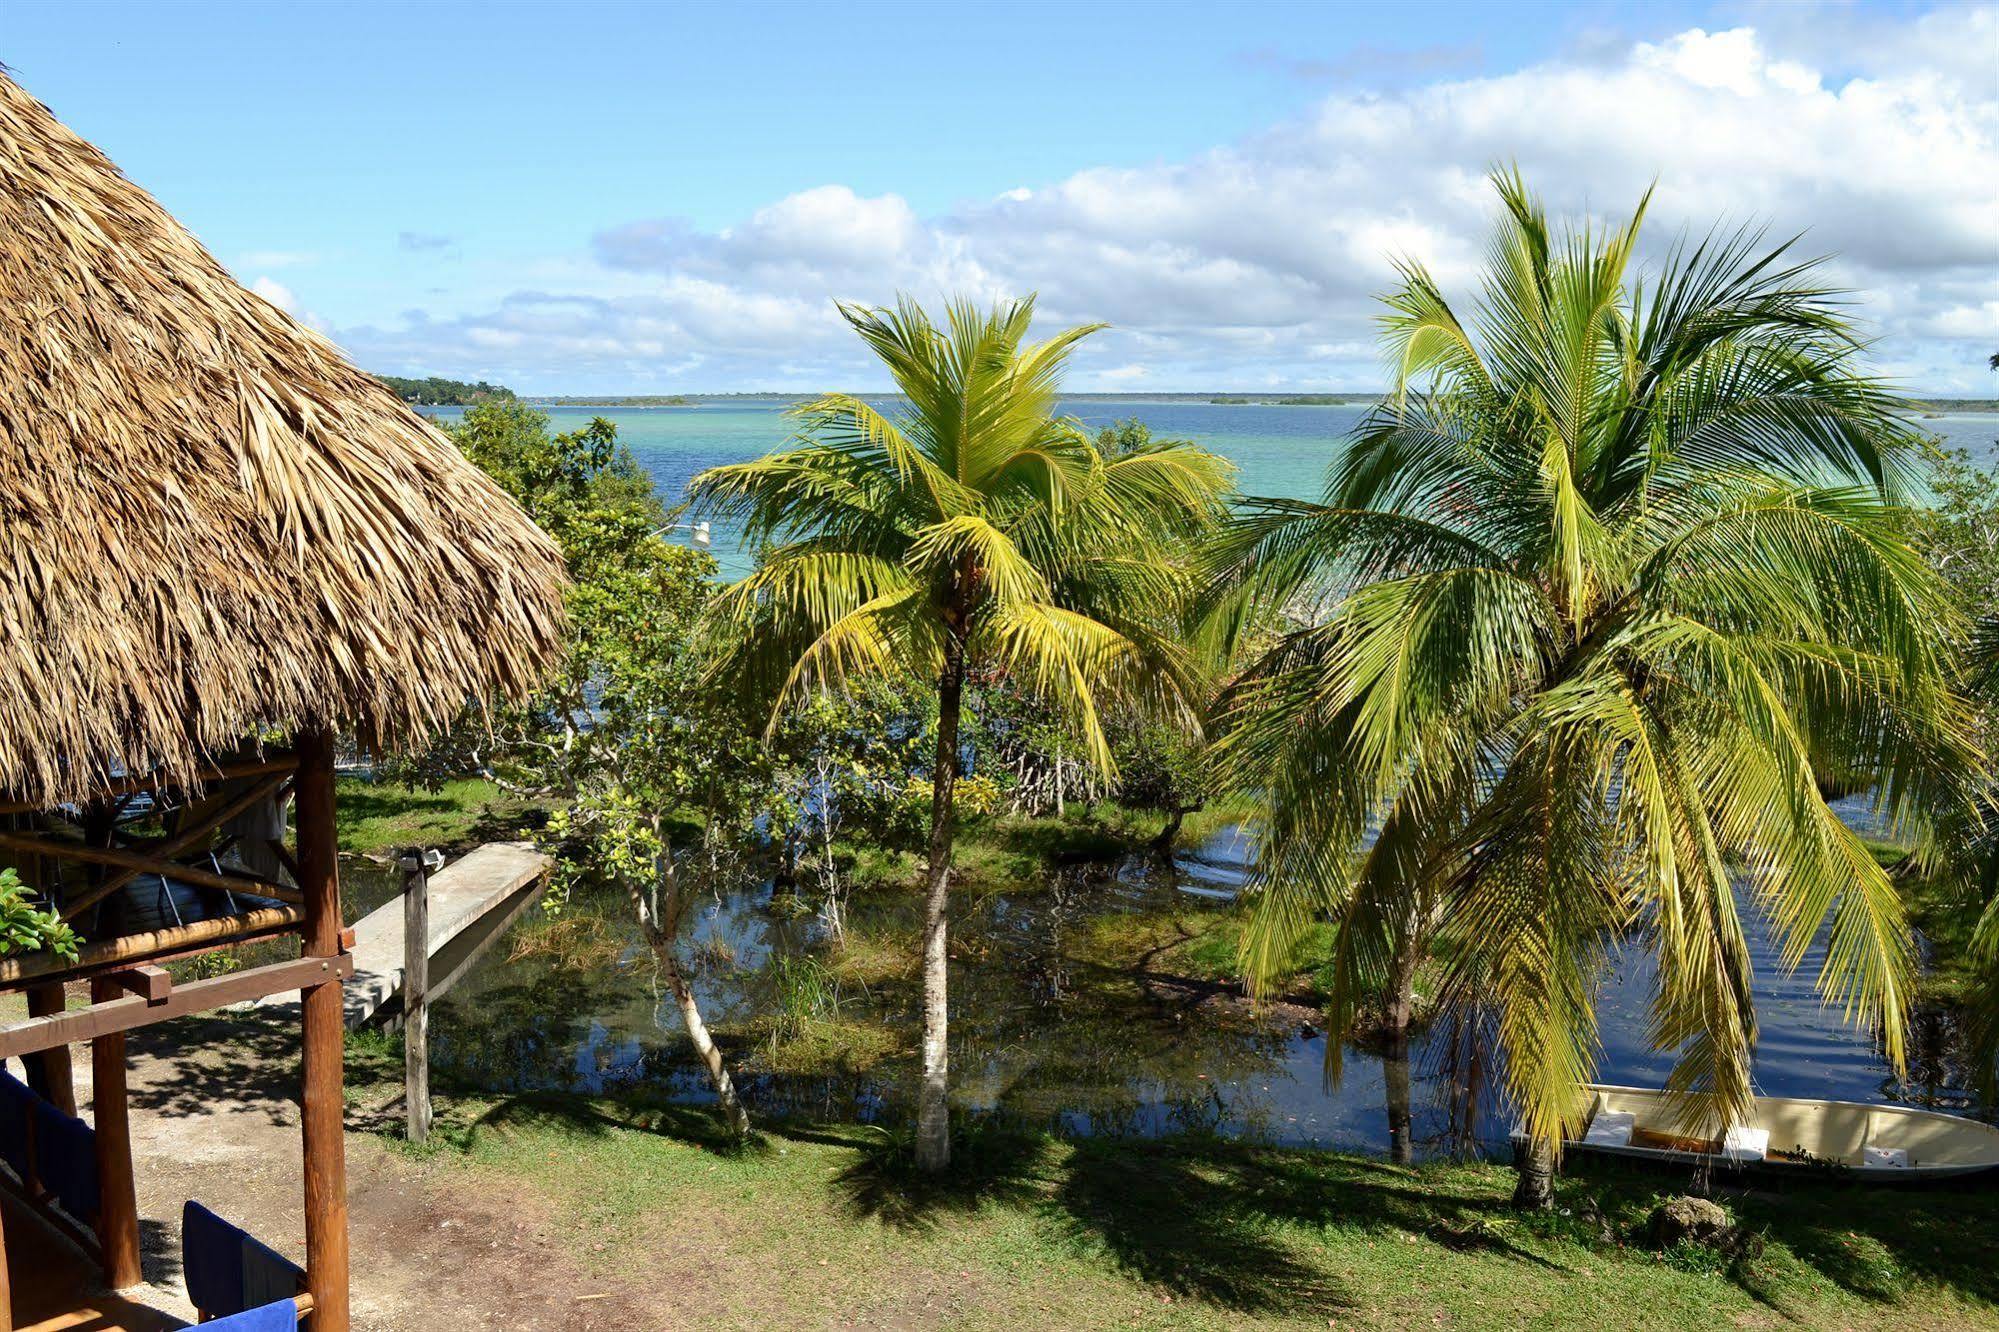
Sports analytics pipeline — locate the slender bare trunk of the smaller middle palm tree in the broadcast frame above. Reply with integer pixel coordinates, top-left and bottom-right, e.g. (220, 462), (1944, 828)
(916, 644), (966, 1170)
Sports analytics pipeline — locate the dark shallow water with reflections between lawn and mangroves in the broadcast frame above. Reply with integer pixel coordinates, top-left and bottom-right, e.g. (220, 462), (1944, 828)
(417, 792), (1981, 1150)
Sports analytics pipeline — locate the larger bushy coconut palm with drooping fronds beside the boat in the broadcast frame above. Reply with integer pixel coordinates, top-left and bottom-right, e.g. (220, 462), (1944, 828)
(1215, 174), (1977, 1202)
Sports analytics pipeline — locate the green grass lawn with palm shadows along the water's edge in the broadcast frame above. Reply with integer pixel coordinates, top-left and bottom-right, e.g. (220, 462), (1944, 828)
(354, 1038), (1999, 1332)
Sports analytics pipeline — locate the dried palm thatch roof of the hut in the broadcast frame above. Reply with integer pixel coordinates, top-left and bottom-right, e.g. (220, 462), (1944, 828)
(0, 74), (564, 804)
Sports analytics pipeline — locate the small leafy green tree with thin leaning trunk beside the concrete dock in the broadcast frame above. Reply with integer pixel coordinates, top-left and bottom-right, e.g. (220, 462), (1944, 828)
(441, 402), (770, 1136)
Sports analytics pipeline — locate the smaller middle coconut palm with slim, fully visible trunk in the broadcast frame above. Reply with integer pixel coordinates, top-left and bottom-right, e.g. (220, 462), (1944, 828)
(694, 298), (1231, 1170)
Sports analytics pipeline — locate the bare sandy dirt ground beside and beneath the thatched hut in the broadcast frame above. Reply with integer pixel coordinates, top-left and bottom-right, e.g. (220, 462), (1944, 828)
(60, 1020), (662, 1332)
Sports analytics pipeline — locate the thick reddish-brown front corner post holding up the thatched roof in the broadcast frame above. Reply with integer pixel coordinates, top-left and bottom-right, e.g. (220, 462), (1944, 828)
(298, 728), (350, 1332)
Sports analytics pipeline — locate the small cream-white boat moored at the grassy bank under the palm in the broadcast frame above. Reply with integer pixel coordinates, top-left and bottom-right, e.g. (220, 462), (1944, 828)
(1567, 1084), (1999, 1184)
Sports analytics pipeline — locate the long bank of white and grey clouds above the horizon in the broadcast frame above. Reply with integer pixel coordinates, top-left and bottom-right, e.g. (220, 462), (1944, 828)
(342, 8), (1999, 392)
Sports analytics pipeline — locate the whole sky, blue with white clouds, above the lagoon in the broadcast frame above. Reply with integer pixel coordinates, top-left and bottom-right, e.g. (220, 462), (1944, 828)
(0, 0), (1999, 392)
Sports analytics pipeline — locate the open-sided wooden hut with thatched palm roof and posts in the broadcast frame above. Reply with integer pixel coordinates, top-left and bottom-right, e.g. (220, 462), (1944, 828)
(0, 74), (564, 1332)
